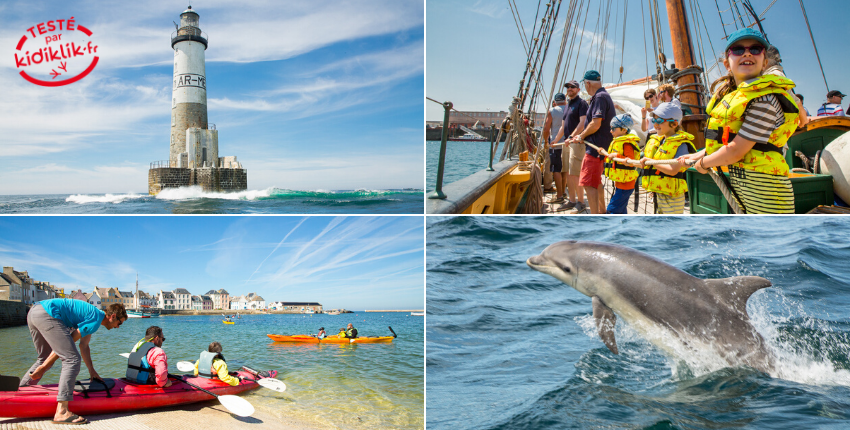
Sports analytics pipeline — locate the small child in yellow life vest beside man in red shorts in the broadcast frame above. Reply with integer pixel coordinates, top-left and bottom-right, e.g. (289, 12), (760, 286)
(605, 114), (640, 214)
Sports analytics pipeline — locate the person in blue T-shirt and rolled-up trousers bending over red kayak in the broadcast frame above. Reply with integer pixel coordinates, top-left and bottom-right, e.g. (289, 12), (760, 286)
(21, 299), (127, 424)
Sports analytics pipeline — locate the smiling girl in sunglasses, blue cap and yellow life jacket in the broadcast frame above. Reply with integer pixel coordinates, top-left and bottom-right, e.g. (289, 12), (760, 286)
(679, 28), (799, 213)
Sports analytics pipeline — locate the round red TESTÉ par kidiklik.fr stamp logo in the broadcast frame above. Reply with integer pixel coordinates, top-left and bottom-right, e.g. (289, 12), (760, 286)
(15, 16), (100, 87)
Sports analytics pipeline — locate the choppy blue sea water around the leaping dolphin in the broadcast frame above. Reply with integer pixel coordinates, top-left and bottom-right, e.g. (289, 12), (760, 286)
(426, 216), (850, 429)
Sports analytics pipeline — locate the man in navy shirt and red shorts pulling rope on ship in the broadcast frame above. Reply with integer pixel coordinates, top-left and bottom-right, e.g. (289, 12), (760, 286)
(571, 70), (616, 214)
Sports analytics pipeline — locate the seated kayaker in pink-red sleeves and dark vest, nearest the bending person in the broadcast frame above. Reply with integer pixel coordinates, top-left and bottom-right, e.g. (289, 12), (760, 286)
(127, 326), (171, 388)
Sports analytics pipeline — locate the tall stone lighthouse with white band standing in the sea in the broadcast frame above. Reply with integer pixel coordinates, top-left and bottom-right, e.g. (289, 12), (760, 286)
(148, 6), (248, 195)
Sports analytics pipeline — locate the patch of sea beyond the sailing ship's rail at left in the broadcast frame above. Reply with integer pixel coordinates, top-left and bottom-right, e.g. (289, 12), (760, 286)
(425, 141), (494, 191)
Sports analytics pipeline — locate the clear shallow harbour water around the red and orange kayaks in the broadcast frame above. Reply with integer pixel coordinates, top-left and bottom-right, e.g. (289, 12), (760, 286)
(0, 312), (425, 429)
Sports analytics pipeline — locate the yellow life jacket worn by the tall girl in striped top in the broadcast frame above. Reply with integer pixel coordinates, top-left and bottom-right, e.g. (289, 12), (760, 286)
(705, 75), (800, 175)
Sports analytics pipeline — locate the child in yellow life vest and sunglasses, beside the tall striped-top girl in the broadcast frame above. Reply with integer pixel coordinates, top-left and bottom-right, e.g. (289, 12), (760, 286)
(640, 103), (696, 214)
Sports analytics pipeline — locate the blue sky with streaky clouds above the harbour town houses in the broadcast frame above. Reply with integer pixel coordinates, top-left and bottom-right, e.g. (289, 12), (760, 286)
(0, 216), (425, 310)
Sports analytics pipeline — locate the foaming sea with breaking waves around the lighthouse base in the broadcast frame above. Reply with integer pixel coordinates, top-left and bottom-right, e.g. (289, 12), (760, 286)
(0, 187), (424, 215)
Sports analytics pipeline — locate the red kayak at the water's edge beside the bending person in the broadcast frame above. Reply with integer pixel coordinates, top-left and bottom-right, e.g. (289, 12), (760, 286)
(0, 368), (260, 418)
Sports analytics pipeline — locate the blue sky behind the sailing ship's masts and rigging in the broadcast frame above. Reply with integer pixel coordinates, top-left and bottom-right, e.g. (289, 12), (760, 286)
(425, 0), (850, 120)
